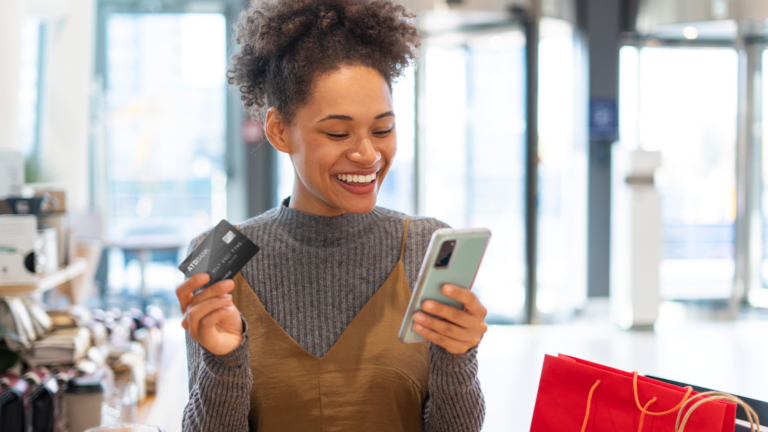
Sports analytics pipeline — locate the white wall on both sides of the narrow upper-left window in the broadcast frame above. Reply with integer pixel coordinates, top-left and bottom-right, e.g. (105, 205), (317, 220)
(0, 0), (95, 212)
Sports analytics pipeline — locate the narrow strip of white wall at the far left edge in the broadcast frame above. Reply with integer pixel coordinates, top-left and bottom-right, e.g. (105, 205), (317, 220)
(0, 0), (25, 149)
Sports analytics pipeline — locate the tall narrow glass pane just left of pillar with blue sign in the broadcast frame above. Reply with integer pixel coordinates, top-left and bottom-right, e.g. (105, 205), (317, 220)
(536, 18), (587, 319)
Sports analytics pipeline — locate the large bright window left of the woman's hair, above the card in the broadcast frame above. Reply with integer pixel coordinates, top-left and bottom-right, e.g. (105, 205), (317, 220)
(106, 14), (226, 240)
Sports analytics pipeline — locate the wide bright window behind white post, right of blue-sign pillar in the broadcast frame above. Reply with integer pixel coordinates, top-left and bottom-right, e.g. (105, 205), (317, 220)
(620, 47), (738, 299)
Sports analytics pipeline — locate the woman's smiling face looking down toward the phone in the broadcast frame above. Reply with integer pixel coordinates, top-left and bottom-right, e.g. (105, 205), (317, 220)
(266, 66), (397, 216)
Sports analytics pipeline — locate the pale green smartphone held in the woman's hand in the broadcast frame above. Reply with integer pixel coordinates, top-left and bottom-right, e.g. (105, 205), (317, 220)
(399, 228), (491, 342)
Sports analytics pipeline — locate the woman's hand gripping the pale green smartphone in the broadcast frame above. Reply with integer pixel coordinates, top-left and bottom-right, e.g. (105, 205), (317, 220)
(413, 284), (488, 354)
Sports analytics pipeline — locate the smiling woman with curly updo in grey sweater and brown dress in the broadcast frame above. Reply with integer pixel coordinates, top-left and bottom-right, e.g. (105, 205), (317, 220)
(177, 0), (486, 432)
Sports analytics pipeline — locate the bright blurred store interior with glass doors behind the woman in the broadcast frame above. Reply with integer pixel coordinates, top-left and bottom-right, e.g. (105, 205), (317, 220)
(0, 0), (768, 431)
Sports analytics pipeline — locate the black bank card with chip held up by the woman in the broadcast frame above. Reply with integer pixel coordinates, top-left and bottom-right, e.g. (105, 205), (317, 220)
(179, 220), (259, 288)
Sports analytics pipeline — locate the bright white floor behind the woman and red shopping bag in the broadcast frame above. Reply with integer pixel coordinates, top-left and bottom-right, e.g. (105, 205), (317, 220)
(146, 305), (768, 432)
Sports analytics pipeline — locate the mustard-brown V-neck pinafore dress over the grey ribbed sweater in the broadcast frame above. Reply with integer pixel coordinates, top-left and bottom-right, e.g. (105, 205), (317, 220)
(232, 218), (429, 432)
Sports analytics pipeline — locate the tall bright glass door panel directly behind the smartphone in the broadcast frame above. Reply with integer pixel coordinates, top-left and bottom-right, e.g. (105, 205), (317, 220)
(417, 27), (526, 323)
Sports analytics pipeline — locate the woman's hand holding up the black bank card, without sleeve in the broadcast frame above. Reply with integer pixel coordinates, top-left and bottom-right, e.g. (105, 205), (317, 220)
(176, 273), (243, 355)
